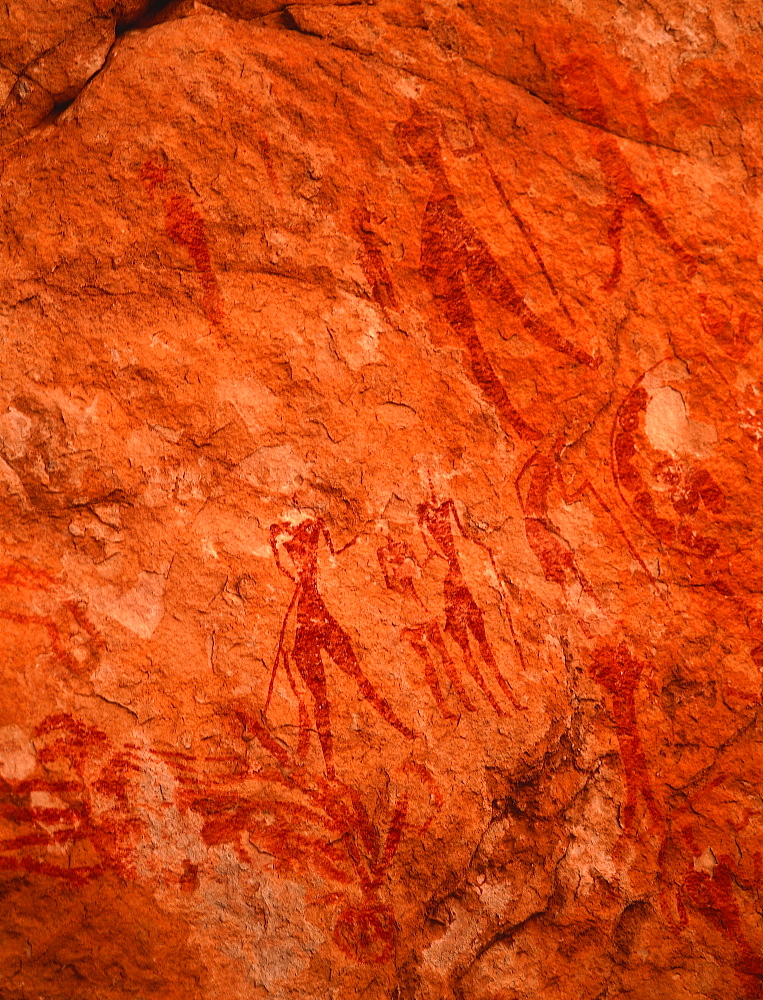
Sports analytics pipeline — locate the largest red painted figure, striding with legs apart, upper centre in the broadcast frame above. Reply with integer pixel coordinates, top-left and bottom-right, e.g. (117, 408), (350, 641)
(395, 101), (598, 440)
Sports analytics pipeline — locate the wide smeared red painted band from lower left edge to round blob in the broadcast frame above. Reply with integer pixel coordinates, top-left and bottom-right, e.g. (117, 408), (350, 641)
(0, 714), (443, 964)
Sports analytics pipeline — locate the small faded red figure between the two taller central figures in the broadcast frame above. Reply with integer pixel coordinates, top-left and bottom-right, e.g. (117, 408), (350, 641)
(376, 536), (475, 719)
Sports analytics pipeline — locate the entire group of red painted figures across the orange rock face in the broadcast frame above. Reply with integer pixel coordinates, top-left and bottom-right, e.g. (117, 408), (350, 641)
(0, 64), (763, 984)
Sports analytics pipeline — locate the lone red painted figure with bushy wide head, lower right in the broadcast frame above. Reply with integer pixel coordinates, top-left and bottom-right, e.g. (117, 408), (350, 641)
(588, 642), (664, 835)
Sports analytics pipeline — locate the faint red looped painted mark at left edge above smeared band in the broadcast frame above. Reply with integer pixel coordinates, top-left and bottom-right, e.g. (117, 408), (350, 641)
(0, 563), (105, 674)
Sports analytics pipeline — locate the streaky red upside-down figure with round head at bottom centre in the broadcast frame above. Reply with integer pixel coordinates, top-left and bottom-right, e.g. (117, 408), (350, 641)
(168, 740), (442, 964)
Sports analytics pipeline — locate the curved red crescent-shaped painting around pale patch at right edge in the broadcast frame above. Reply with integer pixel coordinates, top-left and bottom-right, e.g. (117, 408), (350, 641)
(611, 359), (763, 665)
